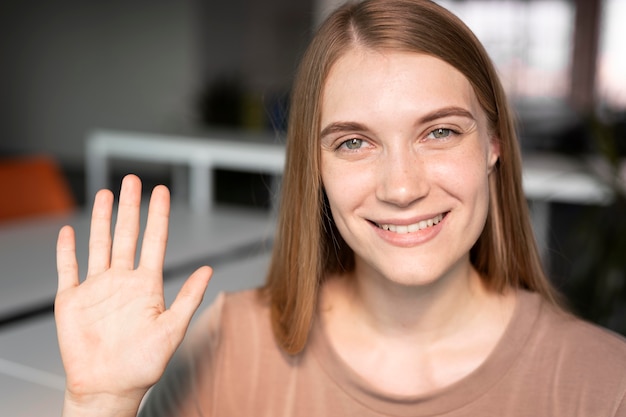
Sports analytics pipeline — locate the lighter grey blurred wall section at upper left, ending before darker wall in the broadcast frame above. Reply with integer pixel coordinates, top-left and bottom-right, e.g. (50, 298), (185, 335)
(0, 0), (195, 164)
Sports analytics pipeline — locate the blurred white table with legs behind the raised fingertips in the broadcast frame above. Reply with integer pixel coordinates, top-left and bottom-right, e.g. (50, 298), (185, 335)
(85, 130), (285, 213)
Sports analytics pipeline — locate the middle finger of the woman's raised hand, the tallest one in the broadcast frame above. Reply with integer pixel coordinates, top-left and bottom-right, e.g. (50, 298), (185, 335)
(111, 175), (141, 269)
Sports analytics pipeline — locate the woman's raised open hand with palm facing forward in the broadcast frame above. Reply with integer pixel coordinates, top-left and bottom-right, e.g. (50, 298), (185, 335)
(55, 175), (211, 416)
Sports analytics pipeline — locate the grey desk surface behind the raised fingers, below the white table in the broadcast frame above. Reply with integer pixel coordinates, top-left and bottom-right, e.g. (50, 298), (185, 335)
(0, 206), (274, 323)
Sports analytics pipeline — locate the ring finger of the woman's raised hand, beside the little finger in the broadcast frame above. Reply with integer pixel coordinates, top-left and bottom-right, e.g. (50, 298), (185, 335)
(87, 190), (113, 276)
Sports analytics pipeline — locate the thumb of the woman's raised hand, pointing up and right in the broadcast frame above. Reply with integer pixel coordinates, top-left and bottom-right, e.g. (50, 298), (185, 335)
(164, 266), (213, 341)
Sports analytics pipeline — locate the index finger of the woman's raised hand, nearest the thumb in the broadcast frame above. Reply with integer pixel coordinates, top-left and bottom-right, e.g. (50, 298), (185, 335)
(139, 185), (170, 272)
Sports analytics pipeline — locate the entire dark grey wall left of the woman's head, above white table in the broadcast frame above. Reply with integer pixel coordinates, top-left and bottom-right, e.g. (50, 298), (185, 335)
(0, 0), (312, 167)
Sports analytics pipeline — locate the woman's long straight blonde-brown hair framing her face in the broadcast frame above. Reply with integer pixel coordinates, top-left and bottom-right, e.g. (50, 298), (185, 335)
(264, 0), (558, 353)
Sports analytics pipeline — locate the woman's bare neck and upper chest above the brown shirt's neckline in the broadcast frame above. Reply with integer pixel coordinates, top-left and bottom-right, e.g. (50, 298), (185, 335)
(320, 255), (515, 395)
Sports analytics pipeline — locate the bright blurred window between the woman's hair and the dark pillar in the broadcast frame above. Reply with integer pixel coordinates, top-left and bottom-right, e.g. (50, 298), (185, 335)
(438, 0), (575, 99)
